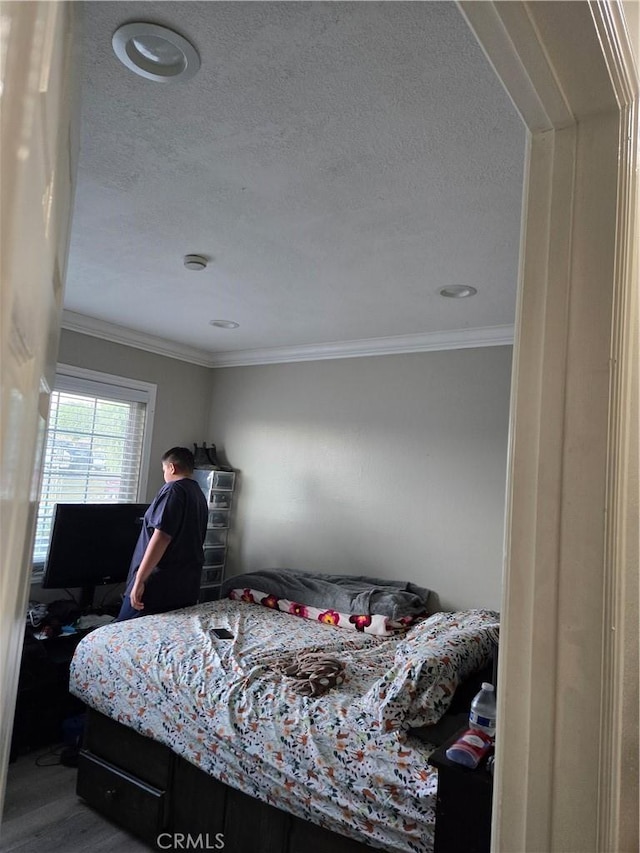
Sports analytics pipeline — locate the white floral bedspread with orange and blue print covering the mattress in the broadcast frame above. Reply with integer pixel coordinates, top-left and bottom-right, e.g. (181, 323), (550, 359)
(70, 600), (498, 853)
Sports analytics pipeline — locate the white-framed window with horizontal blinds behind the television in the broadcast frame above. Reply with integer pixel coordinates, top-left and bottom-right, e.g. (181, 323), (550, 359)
(33, 365), (156, 572)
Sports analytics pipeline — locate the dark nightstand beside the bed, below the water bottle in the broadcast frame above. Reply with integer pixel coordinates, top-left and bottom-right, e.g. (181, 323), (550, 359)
(429, 725), (493, 853)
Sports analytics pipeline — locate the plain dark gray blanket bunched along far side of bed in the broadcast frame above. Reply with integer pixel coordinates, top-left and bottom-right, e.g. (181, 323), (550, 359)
(220, 569), (431, 620)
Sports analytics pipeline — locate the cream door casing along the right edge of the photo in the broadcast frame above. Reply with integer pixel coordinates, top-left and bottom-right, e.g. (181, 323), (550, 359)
(459, 2), (639, 853)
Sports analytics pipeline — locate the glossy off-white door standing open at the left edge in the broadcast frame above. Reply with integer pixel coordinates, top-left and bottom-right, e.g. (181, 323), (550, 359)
(0, 2), (80, 812)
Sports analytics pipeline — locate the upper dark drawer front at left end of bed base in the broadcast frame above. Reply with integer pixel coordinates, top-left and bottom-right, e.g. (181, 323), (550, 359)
(83, 710), (174, 791)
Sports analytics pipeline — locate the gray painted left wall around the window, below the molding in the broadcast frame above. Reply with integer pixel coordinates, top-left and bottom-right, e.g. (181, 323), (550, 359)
(58, 329), (211, 500)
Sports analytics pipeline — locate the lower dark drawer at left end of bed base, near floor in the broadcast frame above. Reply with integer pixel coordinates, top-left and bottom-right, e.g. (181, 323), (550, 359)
(76, 750), (168, 846)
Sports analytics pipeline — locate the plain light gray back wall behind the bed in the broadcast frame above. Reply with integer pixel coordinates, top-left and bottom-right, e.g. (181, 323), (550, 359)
(208, 347), (511, 609)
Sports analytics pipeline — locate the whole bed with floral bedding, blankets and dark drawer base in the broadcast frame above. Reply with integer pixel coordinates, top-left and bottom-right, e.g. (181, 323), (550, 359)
(70, 573), (499, 853)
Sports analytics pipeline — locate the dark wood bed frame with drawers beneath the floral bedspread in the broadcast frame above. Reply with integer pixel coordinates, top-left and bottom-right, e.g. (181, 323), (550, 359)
(77, 666), (492, 853)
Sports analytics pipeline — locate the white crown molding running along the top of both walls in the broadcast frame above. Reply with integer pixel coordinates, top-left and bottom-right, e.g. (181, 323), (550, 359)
(62, 311), (513, 367)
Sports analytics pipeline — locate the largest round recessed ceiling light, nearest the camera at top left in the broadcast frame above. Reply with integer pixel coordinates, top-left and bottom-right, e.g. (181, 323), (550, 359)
(111, 21), (200, 83)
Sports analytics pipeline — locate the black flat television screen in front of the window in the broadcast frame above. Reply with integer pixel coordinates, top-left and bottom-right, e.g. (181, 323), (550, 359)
(42, 504), (149, 589)
